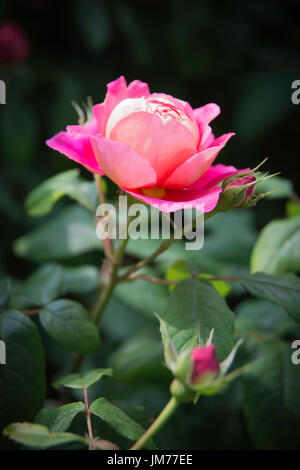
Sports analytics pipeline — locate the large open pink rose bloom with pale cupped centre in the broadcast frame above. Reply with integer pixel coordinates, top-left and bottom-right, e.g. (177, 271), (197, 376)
(47, 77), (237, 212)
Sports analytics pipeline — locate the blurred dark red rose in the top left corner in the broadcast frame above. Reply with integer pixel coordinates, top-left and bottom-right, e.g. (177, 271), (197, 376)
(0, 21), (29, 65)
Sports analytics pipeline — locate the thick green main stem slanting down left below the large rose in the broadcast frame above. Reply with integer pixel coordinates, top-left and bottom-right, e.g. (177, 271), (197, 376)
(92, 237), (128, 323)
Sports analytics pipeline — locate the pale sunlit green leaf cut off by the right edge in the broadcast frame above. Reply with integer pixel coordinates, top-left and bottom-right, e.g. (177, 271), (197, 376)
(251, 216), (300, 274)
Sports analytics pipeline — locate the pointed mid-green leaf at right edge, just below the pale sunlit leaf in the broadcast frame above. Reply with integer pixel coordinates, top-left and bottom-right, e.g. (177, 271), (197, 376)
(238, 273), (300, 322)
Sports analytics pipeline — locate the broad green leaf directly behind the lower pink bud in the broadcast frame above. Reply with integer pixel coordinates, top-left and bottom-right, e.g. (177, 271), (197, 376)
(162, 278), (234, 361)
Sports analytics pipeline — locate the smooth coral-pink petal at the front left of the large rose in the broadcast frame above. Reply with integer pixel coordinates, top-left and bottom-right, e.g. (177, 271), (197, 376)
(91, 134), (157, 189)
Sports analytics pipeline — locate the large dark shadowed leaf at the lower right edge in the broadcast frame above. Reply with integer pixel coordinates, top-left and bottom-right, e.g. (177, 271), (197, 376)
(244, 341), (300, 450)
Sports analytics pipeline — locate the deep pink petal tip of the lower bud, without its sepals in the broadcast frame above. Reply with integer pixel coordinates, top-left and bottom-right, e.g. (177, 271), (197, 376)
(191, 344), (220, 383)
